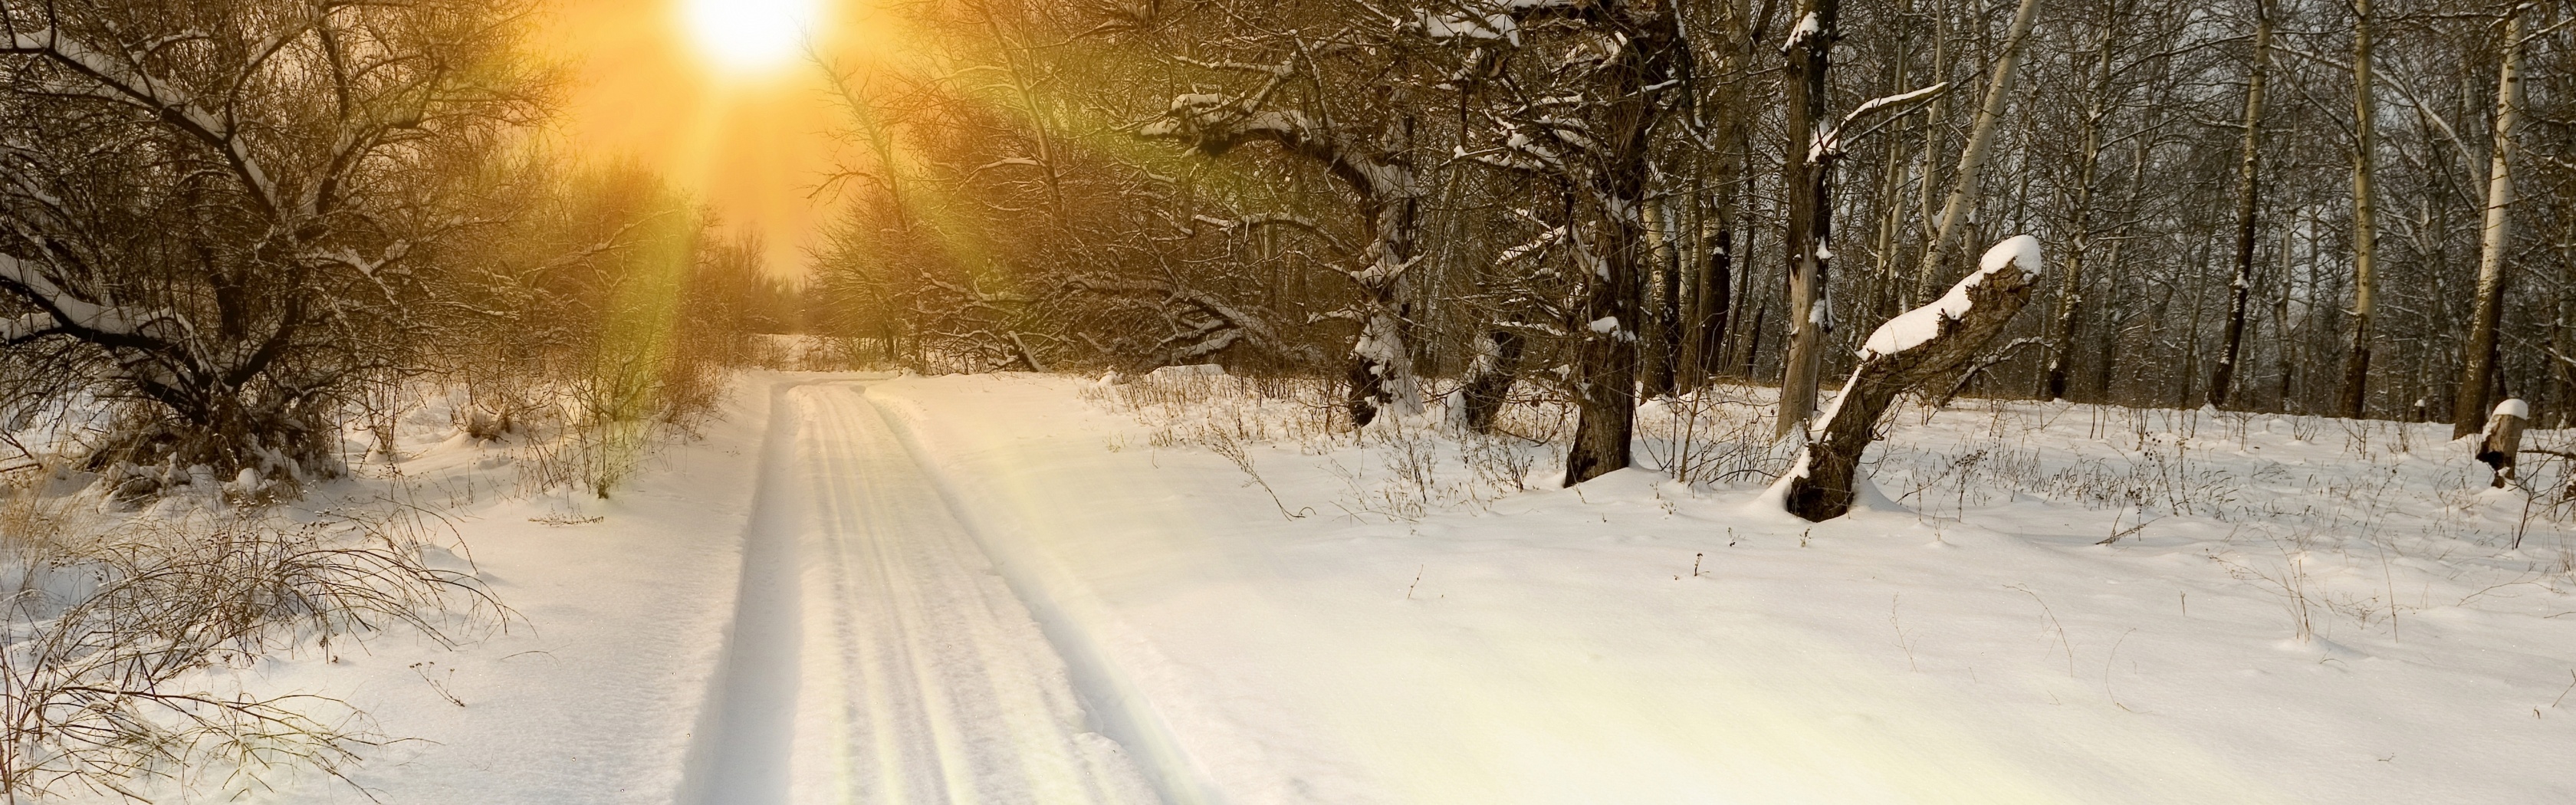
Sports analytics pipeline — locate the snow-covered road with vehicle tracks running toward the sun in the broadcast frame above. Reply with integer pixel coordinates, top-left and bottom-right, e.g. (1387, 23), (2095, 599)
(685, 382), (1157, 805)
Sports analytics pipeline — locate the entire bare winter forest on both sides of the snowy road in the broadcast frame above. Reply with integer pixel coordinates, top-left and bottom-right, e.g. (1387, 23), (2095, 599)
(0, 0), (2576, 503)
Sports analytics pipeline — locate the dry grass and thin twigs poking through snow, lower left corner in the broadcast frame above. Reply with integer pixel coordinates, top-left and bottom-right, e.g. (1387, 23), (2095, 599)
(0, 405), (508, 803)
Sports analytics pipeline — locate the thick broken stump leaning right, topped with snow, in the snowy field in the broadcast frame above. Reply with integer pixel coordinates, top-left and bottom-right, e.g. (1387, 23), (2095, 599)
(1780, 235), (2040, 521)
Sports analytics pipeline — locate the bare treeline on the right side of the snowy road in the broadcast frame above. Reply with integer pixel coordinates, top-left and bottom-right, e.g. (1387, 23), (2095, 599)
(816, 0), (2576, 480)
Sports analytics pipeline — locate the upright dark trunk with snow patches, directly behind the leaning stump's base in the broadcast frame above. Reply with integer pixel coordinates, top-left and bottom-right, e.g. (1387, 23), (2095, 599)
(1775, 0), (1842, 439)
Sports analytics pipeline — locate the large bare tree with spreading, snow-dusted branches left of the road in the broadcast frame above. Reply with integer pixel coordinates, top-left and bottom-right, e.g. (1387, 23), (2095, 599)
(0, 0), (531, 478)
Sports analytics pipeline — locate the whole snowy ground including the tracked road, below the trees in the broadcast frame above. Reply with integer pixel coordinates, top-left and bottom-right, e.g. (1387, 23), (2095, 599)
(40, 374), (2576, 803)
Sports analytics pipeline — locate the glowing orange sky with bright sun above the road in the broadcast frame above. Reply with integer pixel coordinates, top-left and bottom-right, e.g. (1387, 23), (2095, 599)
(531, 0), (871, 276)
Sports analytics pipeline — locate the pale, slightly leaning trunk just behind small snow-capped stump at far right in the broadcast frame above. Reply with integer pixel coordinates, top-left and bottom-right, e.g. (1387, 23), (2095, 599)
(2450, 5), (2522, 439)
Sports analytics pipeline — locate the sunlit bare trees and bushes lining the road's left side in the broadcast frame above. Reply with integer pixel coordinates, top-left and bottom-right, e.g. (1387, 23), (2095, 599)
(0, 0), (794, 495)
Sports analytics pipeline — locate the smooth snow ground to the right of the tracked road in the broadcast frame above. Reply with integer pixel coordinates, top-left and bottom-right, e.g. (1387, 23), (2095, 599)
(871, 376), (2576, 803)
